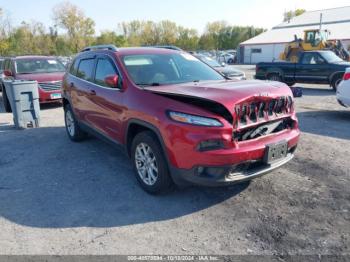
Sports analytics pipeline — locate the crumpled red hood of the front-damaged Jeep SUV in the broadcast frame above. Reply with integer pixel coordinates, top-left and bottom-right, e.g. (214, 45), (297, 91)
(145, 80), (293, 112)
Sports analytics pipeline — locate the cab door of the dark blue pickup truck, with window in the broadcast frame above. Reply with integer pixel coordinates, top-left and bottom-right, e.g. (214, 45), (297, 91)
(295, 52), (330, 83)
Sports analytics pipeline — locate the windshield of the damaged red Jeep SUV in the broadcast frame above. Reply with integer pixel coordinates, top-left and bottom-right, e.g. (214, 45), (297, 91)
(123, 53), (224, 86)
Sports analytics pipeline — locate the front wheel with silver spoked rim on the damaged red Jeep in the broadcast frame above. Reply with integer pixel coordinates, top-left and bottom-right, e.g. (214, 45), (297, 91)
(131, 131), (171, 194)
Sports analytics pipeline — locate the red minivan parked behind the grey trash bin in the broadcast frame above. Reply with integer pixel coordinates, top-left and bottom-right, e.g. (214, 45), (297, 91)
(0, 56), (65, 112)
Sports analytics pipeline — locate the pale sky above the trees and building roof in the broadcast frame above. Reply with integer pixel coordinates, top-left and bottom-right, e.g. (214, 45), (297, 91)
(0, 0), (350, 33)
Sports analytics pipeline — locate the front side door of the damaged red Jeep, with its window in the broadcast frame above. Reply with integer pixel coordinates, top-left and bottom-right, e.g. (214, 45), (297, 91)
(86, 55), (123, 142)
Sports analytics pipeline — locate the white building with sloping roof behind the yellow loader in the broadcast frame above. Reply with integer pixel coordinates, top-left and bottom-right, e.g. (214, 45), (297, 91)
(238, 6), (350, 64)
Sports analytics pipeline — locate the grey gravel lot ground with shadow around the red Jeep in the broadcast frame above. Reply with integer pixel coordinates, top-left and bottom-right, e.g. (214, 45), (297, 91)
(0, 67), (350, 255)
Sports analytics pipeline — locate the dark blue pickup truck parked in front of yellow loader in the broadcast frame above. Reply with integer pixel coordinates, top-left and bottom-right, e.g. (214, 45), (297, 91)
(255, 50), (350, 90)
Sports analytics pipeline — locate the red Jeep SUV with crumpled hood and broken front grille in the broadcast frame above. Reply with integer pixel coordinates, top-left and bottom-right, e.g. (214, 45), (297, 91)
(62, 46), (299, 193)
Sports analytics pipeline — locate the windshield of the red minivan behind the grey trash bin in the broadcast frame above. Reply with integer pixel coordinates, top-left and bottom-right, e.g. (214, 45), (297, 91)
(16, 58), (65, 74)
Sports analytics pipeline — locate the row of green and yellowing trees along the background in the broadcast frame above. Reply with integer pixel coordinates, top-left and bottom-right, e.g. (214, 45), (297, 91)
(0, 2), (265, 56)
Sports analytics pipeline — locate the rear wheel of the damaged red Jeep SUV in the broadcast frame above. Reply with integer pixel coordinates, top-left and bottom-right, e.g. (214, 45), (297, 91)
(64, 104), (87, 142)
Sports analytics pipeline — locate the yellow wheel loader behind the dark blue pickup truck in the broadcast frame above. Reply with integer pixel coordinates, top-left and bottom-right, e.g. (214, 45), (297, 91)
(279, 29), (350, 63)
